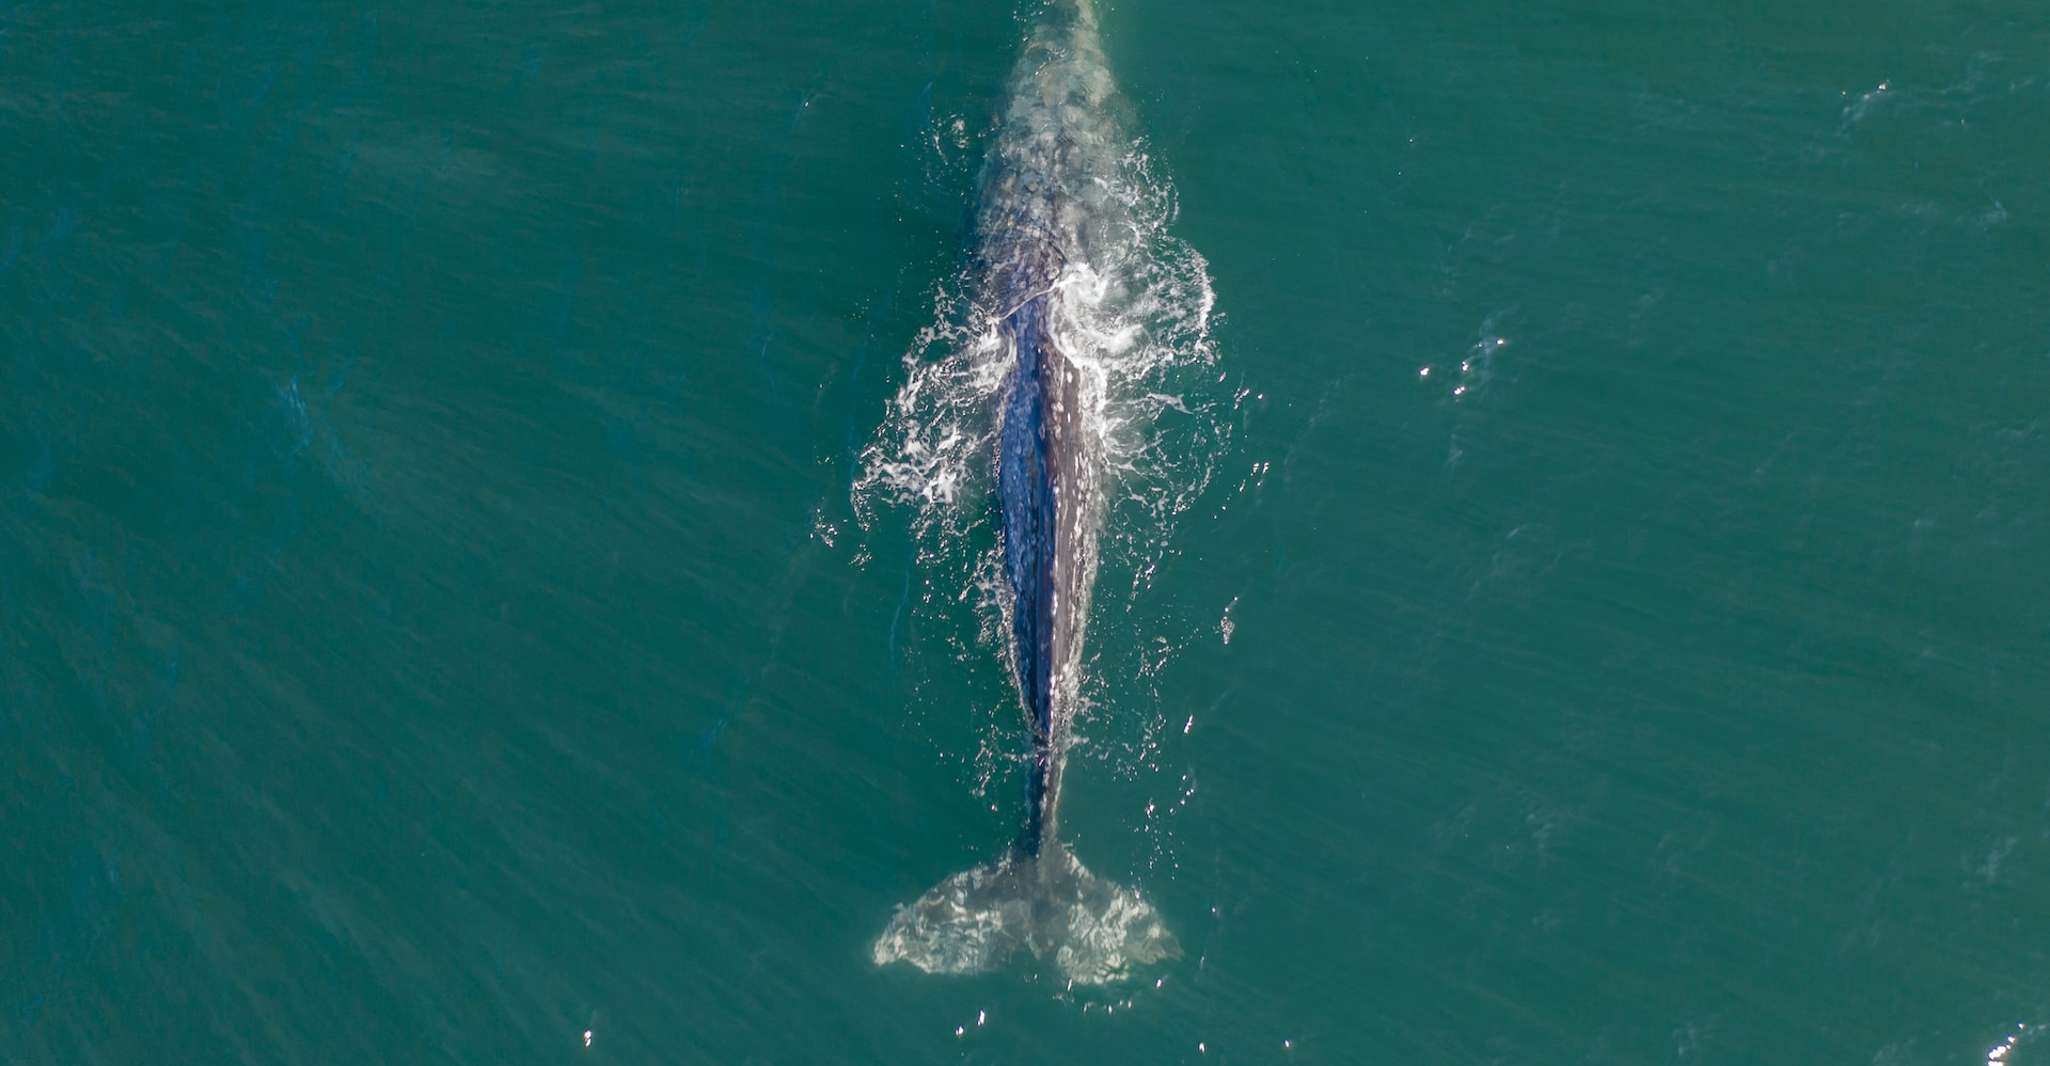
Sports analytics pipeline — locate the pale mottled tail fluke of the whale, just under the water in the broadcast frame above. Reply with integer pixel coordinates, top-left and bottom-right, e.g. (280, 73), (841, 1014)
(875, 845), (1181, 984)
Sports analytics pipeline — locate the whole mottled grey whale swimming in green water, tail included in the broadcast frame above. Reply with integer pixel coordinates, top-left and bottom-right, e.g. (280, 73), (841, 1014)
(873, 0), (1181, 986)
